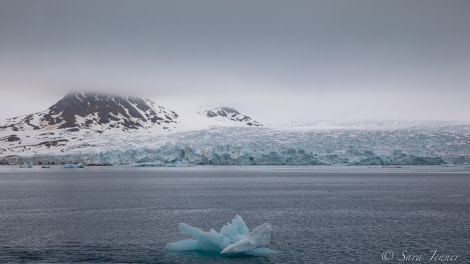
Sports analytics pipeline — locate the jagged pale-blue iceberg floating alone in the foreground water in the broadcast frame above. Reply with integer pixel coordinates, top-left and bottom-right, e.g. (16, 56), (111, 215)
(166, 215), (272, 254)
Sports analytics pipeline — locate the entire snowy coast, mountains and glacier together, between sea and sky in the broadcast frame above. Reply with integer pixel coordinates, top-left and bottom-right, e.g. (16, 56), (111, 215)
(0, 93), (470, 166)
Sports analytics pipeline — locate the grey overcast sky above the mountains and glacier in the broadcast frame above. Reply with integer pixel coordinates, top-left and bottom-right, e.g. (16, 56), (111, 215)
(0, 0), (470, 124)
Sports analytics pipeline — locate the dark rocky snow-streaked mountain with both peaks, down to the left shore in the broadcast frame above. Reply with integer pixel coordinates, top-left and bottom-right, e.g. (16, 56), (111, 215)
(0, 93), (260, 163)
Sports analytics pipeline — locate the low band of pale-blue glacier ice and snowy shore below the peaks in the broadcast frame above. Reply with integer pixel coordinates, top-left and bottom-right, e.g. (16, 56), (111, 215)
(0, 124), (470, 167)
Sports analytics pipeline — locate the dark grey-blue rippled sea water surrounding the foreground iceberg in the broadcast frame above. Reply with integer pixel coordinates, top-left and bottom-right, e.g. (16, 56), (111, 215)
(0, 167), (470, 263)
